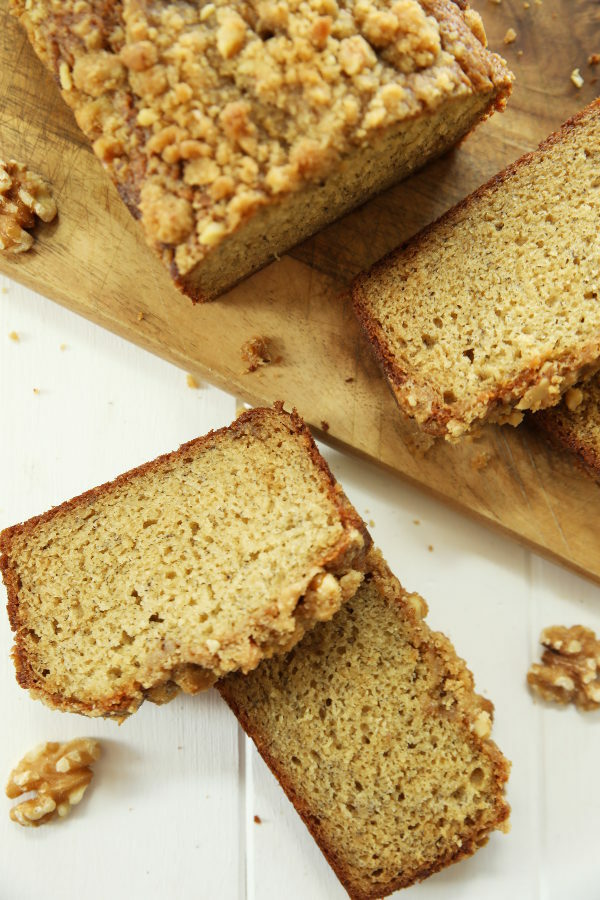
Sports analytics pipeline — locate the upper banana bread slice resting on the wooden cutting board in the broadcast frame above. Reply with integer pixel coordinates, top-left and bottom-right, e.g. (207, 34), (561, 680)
(354, 101), (600, 439)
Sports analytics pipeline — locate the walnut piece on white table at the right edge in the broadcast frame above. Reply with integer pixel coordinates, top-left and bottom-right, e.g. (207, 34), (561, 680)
(527, 625), (600, 710)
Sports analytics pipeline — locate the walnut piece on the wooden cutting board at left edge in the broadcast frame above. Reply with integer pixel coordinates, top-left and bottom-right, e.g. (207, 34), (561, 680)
(0, 159), (56, 253)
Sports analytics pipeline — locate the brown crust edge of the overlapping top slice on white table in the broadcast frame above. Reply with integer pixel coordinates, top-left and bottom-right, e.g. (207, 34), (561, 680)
(0, 401), (371, 719)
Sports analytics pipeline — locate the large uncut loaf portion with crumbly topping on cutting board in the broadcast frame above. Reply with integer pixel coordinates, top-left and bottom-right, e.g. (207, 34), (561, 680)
(10, 0), (512, 299)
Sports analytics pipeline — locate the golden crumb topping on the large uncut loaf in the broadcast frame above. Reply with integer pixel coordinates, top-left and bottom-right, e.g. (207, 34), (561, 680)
(13, 0), (502, 275)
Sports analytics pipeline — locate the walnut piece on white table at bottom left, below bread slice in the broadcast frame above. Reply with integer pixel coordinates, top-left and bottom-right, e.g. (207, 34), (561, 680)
(6, 738), (100, 828)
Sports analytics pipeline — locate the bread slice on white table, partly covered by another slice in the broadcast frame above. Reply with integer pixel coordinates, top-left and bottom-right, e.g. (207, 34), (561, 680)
(217, 550), (509, 900)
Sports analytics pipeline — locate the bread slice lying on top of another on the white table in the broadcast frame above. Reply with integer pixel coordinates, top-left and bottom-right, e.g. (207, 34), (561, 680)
(0, 406), (369, 717)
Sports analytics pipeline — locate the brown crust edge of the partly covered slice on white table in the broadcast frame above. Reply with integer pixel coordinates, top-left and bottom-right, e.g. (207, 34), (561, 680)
(217, 548), (510, 900)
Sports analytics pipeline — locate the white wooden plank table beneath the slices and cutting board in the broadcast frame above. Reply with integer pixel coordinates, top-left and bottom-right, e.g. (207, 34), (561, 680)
(0, 276), (600, 900)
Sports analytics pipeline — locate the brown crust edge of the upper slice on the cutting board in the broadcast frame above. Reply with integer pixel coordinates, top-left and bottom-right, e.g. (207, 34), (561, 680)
(352, 98), (600, 436)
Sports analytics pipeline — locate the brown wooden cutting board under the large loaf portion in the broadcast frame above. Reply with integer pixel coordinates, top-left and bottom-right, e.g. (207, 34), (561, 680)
(0, 0), (600, 581)
